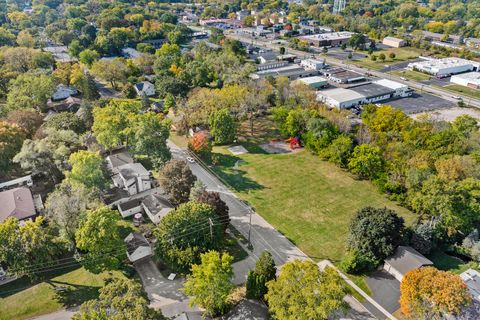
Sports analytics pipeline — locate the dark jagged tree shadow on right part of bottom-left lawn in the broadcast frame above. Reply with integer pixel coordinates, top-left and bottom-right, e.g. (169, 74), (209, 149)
(47, 281), (100, 308)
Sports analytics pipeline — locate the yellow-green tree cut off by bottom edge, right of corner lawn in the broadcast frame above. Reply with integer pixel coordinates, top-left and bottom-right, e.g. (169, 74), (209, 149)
(72, 278), (166, 320)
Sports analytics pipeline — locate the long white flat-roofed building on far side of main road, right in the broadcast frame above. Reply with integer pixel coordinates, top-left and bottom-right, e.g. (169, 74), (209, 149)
(407, 58), (480, 78)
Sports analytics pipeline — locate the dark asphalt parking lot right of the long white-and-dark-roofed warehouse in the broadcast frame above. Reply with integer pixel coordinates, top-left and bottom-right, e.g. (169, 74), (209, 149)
(385, 92), (456, 114)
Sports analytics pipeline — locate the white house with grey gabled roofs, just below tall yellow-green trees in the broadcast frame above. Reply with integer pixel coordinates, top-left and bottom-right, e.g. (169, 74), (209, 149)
(112, 163), (152, 196)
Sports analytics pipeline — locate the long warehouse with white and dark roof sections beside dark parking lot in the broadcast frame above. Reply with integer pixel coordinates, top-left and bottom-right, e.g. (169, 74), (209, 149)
(317, 79), (413, 109)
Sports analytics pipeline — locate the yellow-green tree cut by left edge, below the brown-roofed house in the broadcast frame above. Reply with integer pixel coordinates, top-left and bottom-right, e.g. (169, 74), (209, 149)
(0, 216), (62, 277)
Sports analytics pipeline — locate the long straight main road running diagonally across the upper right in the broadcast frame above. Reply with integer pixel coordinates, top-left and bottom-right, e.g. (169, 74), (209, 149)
(226, 33), (480, 108)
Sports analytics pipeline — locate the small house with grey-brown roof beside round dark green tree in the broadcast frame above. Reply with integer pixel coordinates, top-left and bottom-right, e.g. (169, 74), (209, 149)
(383, 246), (433, 282)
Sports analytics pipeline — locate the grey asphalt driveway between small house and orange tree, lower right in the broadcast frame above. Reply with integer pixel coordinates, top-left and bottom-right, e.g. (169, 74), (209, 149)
(366, 270), (400, 313)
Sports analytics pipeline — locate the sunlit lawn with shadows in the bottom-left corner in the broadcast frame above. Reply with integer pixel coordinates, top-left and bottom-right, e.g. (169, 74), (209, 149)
(0, 267), (123, 320)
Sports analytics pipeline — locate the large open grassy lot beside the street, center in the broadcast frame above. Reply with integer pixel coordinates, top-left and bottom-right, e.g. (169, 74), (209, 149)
(214, 144), (415, 262)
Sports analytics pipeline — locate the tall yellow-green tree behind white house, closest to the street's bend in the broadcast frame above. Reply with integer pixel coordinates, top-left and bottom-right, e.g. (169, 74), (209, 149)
(130, 112), (172, 169)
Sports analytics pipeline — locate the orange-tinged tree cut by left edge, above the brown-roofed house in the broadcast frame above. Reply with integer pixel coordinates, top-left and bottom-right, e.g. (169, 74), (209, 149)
(0, 121), (25, 176)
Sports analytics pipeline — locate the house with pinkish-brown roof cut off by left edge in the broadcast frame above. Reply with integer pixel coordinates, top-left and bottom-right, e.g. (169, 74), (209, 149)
(0, 187), (37, 222)
